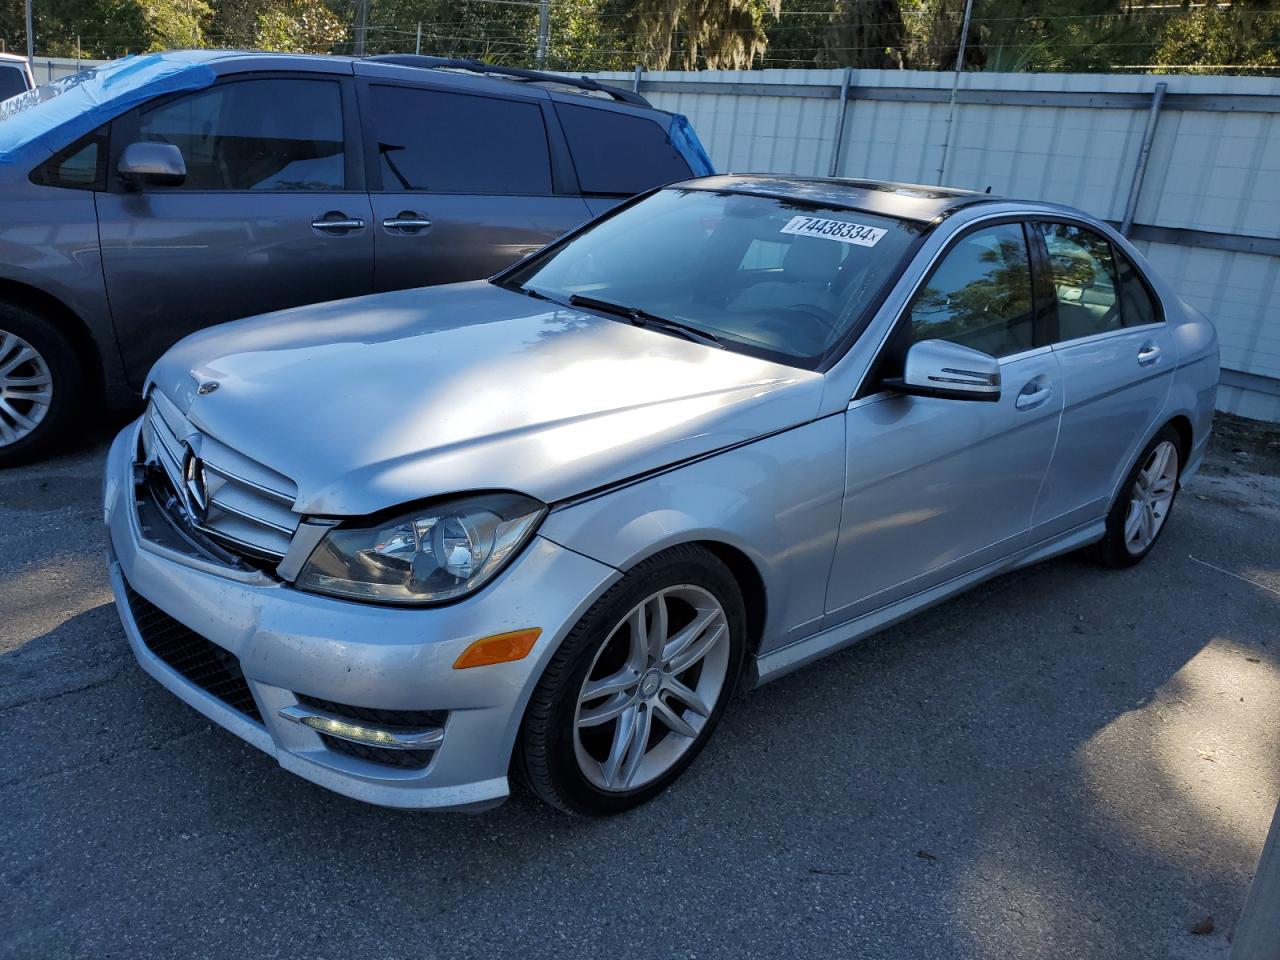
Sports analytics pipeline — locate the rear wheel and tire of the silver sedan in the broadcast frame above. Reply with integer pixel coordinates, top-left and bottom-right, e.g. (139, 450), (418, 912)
(1096, 424), (1187, 568)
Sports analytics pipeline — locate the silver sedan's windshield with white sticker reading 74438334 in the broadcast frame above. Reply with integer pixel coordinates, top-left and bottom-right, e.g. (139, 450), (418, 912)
(499, 188), (923, 369)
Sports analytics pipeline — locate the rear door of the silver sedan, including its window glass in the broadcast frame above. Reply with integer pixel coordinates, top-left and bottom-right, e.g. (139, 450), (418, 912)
(1034, 221), (1178, 539)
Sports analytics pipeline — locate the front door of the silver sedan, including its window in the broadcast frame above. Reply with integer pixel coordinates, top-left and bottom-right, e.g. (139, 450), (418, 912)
(826, 223), (1062, 626)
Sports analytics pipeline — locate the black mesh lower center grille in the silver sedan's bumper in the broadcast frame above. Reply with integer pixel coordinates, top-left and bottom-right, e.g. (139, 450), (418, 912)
(124, 582), (262, 723)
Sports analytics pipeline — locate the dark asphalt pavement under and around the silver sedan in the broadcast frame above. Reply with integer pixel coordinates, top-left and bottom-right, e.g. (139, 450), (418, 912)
(0, 422), (1280, 960)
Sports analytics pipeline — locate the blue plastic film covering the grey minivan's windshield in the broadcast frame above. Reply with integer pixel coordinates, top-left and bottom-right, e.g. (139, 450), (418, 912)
(0, 54), (215, 164)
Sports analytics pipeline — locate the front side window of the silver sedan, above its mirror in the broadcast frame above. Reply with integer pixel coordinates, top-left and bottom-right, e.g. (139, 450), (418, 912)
(911, 224), (1034, 357)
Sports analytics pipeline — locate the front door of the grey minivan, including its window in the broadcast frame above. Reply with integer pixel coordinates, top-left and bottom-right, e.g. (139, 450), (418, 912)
(97, 74), (374, 385)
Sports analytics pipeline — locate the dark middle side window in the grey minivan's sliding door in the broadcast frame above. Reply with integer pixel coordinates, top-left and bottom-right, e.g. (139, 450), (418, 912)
(371, 84), (552, 196)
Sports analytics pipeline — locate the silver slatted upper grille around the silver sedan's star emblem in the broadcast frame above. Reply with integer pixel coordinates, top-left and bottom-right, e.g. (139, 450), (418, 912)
(142, 392), (298, 561)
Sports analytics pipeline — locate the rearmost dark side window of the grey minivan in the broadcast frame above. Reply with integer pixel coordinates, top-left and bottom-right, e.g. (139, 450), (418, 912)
(556, 104), (694, 197)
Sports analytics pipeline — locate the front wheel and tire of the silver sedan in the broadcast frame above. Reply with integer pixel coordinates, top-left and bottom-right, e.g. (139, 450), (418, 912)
(513, 545), (746, 817)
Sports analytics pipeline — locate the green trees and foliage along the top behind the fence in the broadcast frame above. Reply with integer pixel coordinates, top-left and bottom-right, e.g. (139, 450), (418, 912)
(0, 0), (1280, 76)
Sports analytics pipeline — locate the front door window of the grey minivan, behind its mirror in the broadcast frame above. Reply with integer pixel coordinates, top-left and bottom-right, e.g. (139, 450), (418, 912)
(138, 78), (346, 191)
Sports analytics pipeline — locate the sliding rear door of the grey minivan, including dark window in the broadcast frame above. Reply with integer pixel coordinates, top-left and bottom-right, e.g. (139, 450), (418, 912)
(360, 78), (589, 291)
